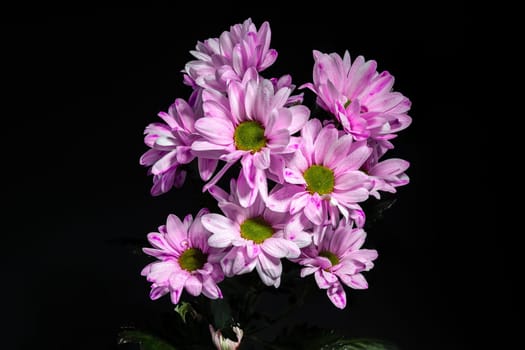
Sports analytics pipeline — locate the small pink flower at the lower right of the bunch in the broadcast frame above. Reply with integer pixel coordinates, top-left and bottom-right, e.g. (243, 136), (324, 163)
(294, 221), (377, 309)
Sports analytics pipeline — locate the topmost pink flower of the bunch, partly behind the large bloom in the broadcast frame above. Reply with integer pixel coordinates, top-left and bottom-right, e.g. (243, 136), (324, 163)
(184, 18), (277, 91)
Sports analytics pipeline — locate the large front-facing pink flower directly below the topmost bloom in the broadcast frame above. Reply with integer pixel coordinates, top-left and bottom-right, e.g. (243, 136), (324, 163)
(192, 70), (310, 207)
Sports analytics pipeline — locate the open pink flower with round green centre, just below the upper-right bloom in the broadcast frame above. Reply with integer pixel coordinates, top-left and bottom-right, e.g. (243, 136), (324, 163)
(267, 119), (372, 226)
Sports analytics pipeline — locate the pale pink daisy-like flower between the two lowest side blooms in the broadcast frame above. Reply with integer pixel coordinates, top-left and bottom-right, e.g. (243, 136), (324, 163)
(202, 180), (312, 288)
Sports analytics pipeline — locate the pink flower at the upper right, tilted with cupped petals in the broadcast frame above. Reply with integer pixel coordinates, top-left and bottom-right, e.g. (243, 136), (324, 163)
(302, 51), (412, 144)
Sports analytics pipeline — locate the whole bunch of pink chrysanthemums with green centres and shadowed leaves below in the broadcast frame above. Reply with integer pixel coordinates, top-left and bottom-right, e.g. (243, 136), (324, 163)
(122, 19), (411, 349)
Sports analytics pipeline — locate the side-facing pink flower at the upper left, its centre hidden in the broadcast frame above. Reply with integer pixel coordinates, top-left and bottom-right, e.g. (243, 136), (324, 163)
(140, 99), (217, 196)
